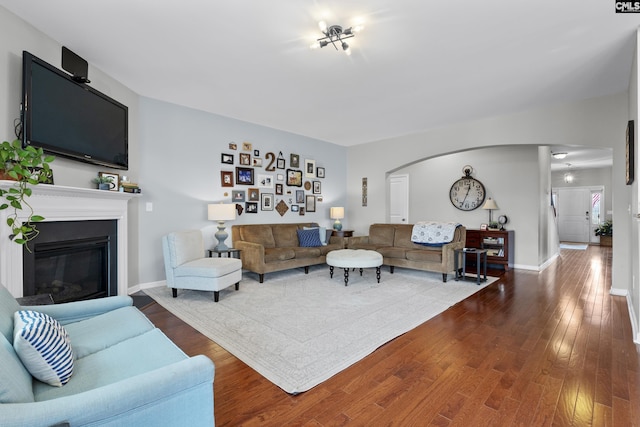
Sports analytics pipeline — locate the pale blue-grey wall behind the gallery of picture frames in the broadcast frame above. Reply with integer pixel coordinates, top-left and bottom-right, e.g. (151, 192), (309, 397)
(139, 98), (349, 283)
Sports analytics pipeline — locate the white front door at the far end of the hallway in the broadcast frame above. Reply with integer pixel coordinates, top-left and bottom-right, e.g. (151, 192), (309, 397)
(557, 188), (591, 243)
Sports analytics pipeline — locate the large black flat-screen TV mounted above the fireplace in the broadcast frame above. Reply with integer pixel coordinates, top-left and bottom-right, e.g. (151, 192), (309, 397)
(22, 51), (129, 169)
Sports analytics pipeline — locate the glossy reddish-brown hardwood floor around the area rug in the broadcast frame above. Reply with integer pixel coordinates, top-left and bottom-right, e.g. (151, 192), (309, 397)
(143, 246), (640, 426)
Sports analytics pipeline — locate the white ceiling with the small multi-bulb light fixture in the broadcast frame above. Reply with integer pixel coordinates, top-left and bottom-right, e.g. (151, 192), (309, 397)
(0, 0), (640, 169)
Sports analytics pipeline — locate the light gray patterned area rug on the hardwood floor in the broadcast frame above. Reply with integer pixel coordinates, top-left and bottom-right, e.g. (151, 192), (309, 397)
(145, 266), (496, 394)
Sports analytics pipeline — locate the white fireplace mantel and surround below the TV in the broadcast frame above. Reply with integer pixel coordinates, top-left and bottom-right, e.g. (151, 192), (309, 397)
(0, 181), (136, 297)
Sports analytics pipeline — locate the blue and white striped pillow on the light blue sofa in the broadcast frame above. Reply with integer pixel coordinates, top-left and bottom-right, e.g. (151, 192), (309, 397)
(13, 310), (73, 387)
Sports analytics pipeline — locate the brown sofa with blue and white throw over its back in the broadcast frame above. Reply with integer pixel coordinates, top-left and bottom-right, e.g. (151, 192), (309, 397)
(348, 224), (467, 282)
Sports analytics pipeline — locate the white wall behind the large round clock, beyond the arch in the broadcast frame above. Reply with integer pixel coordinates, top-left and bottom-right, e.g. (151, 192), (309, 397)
(396, 146), (538, 269)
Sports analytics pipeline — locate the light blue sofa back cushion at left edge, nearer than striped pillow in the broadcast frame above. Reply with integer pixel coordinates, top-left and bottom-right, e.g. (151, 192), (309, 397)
(0, 336), (33, 404)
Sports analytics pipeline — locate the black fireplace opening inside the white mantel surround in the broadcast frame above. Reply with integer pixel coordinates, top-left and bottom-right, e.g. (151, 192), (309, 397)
(23, 220), (118, 303)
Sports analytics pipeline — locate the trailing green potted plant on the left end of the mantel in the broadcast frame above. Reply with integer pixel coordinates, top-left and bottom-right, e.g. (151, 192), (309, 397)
(0, 139), (55, 250)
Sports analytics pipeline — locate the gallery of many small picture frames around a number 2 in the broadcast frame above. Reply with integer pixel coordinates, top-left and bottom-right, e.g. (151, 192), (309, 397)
(220, 141), (326, 216)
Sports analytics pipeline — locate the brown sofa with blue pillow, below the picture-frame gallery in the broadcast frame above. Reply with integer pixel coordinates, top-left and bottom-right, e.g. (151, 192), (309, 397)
(231, 223), (344, 283)
